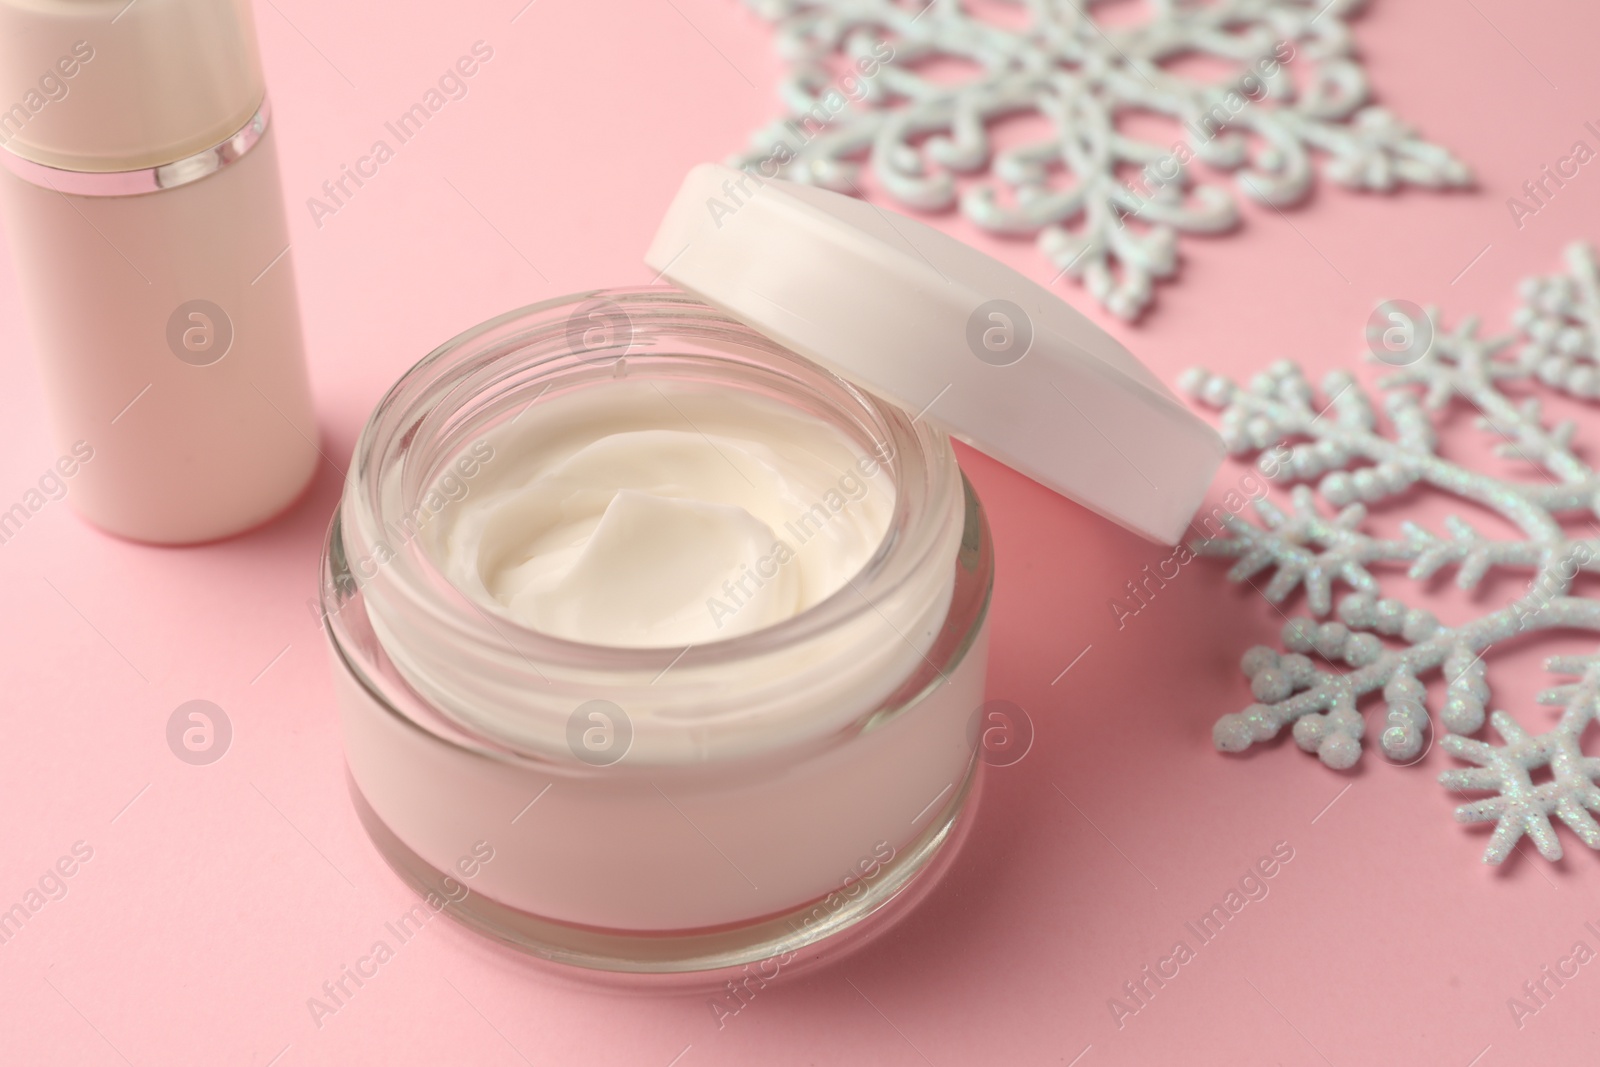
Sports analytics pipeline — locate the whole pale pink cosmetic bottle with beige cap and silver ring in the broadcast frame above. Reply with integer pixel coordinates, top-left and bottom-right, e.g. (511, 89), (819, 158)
(0, 0), (318, 544)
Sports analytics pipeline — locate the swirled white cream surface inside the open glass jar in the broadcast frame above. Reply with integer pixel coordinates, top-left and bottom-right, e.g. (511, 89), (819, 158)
(430, 381), (894, 648)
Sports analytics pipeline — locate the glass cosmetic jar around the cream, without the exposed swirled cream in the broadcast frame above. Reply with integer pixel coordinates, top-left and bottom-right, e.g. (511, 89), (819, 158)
(320, 288), (994, 974)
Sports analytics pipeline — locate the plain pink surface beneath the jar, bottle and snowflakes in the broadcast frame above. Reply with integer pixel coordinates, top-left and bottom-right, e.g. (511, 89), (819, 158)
(0, 0), (1600, 1067)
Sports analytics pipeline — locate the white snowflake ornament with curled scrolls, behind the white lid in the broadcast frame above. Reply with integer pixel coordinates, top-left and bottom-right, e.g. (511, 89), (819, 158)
(731, 0), (1470, 318)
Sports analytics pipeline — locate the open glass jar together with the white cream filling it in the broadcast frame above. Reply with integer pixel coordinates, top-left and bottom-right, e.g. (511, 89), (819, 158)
(323, 290), (994, 971)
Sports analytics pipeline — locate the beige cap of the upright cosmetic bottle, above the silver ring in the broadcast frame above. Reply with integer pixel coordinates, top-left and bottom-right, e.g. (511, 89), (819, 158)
(0, 0), (266, 173)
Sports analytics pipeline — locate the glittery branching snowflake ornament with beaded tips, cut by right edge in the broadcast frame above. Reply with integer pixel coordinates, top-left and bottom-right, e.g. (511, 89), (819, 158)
(1181, 245), (1600, 864)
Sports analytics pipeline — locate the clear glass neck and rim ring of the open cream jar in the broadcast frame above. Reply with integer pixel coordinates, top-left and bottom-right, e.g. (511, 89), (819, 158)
(322, 286), (992, 773)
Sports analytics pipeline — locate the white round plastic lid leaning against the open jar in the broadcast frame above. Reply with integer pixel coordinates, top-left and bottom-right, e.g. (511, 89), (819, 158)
(645, 163), (1224, 544)
